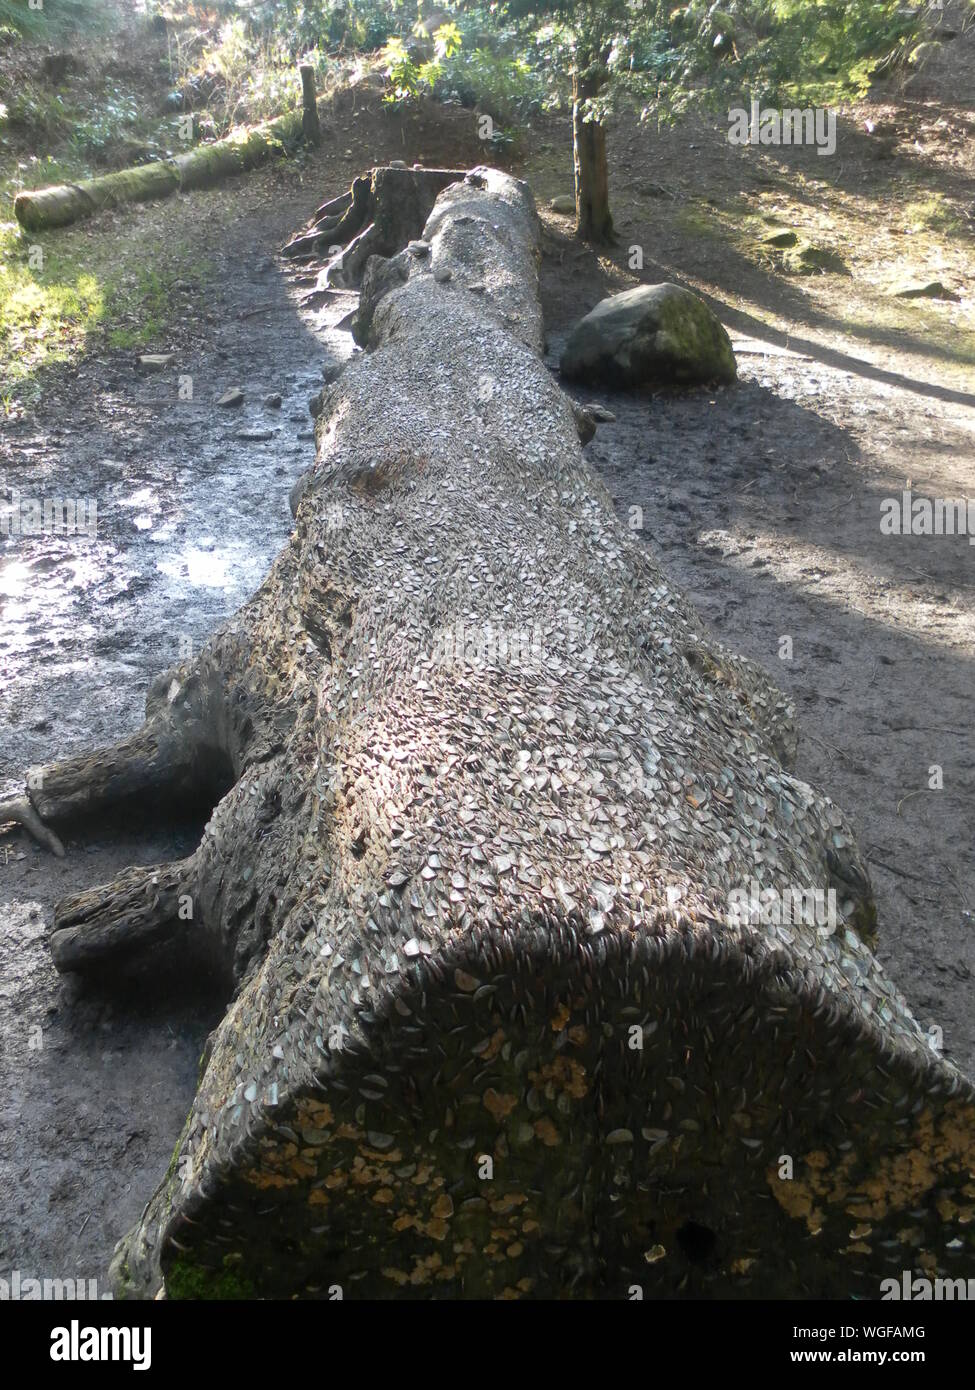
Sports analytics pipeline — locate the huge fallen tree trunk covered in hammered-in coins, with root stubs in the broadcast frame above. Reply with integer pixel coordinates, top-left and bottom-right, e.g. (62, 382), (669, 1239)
(9, 171), (975, 1298)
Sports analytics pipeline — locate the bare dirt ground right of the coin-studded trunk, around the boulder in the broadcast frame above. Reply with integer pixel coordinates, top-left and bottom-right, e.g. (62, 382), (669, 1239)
(535, 86), (975, 1073)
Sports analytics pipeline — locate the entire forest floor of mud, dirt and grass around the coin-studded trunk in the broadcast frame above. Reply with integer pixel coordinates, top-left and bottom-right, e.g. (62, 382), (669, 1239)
(0, 16), (975, 1282)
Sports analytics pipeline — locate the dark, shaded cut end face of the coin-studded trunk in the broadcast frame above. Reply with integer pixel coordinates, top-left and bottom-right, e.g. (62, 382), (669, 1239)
(116, 922), (975, 1300)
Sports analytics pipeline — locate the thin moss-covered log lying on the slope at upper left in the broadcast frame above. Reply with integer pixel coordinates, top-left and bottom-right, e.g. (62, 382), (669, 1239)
(14, 111), (302, 232)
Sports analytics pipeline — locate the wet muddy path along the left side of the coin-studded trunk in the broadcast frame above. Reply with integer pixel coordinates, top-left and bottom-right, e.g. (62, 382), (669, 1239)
(0, 157), (350, 1279)
